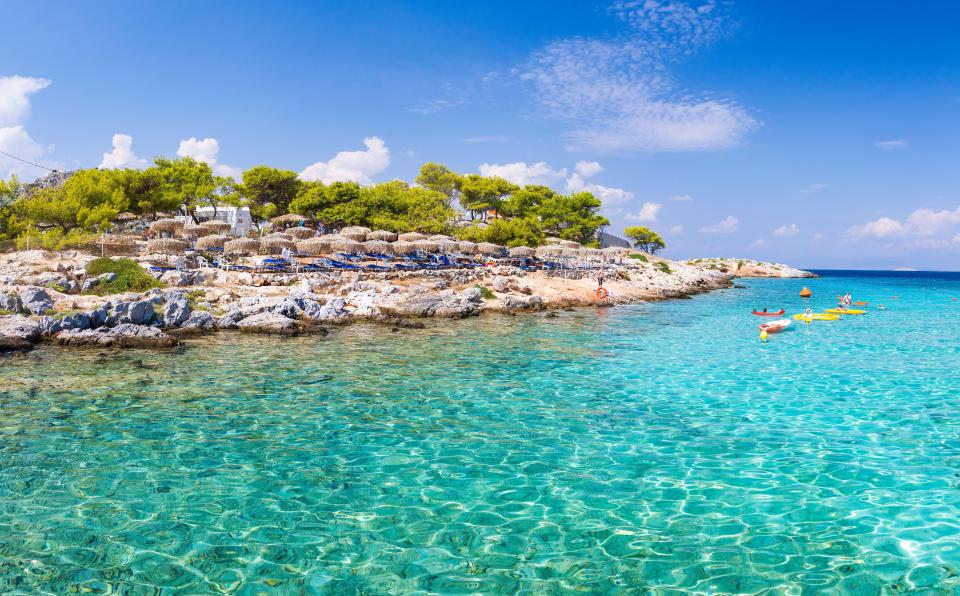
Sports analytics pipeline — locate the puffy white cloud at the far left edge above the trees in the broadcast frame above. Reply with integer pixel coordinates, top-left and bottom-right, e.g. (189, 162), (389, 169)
(0, 76), (51, 178)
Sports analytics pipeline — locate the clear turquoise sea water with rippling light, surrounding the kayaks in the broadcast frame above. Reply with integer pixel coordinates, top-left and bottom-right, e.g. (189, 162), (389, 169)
(0, 275), (960, 594)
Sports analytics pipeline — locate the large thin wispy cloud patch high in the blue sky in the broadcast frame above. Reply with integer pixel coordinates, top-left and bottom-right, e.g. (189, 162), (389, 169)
(519, 0), (759, 151)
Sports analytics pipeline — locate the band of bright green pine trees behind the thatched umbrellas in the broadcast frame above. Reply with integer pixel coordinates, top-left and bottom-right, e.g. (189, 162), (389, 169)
(0, 157), (609, 249)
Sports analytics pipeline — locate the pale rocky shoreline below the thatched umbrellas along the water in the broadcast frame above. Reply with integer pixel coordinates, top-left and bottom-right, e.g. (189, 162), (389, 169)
(0, 251), (811, 352)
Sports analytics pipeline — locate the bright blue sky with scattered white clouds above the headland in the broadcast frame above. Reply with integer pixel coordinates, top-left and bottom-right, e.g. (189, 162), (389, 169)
(0, 0), (960, 270)
